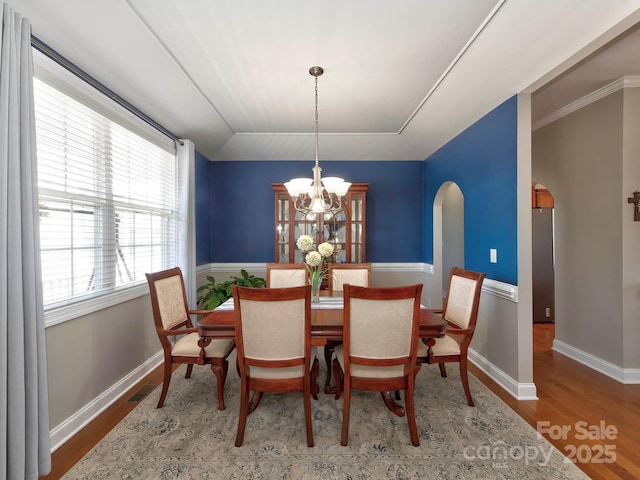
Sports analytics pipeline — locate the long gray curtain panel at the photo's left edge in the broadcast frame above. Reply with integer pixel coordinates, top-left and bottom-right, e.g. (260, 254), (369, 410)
(0, 4), (51, 480)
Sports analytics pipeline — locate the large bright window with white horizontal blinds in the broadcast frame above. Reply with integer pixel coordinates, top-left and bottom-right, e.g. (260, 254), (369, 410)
(34, 74), (177, 310)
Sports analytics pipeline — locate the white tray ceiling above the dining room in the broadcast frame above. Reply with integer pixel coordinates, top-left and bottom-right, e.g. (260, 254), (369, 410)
(8, 0), (640, 160)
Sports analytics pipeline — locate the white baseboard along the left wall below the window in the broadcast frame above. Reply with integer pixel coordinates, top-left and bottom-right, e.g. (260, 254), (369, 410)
(49, 350), (164, 452)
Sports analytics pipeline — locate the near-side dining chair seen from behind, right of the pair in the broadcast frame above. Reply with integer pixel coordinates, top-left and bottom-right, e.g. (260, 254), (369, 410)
(333, 284), (422, 446)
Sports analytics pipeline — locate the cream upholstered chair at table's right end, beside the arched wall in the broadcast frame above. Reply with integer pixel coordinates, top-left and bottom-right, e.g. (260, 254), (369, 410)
(418, 267), (485, 407)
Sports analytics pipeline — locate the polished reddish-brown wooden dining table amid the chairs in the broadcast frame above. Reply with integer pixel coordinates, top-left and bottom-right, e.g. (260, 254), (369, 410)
(198, 296), (447, 416)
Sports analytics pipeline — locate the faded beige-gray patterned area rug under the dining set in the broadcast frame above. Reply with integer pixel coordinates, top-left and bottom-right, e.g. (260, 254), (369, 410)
(64, 350), (588, 480)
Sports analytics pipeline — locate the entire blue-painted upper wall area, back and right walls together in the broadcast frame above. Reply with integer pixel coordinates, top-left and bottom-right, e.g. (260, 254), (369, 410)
(196, 96), (518, 285)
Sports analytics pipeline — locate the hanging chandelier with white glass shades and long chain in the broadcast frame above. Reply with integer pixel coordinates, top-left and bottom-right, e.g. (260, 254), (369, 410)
(284, 66), (351, 215)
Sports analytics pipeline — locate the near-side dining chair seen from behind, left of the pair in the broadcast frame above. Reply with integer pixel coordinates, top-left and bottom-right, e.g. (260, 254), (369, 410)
(233, 285), (318, 447)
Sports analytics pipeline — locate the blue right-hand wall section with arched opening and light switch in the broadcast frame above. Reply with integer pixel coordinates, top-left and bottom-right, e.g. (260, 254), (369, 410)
(424, 96), (518, 285)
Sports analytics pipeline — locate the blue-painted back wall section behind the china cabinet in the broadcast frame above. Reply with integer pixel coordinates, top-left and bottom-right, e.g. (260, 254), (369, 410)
(196, 160), (424, 265)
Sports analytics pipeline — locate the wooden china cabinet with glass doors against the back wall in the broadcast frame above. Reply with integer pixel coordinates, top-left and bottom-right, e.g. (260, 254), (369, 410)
(272, 183), (368, 263)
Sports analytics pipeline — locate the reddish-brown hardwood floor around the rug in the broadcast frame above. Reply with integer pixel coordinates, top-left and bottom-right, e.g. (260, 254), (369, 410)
(40, 324), (640, 480)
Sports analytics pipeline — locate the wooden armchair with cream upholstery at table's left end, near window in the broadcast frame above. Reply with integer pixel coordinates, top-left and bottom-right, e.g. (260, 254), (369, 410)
(146, 267), (235, 410)
